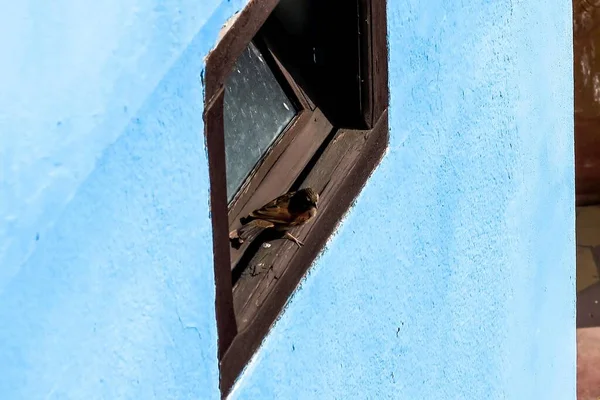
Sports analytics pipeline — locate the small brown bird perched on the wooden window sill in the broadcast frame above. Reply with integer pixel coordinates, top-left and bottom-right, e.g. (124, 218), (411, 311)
(229, 188), (319, 247)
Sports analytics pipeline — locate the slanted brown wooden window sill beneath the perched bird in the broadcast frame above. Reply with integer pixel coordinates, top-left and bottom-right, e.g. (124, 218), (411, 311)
(221, 111), (388, 387)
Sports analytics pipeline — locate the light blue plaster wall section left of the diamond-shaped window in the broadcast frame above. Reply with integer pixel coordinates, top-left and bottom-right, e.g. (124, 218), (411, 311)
(0, 0), (245, 400)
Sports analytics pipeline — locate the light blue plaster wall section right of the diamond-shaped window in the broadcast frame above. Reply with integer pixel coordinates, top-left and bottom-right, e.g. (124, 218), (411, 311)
(232, 0), (575, 400)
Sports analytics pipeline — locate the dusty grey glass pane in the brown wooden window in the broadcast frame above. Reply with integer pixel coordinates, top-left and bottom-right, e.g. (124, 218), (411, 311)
(223, 43), (297, 201)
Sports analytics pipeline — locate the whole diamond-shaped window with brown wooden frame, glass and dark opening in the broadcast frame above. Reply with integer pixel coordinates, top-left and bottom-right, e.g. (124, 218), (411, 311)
(203, 0), (388, 396)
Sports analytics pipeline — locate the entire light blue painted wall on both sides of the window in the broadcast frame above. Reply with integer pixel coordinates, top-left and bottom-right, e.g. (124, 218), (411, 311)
(0, 0), (575, 400)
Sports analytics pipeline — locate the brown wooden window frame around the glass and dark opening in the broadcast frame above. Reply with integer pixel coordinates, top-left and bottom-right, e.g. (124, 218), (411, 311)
(203, 0), (388, 397)
